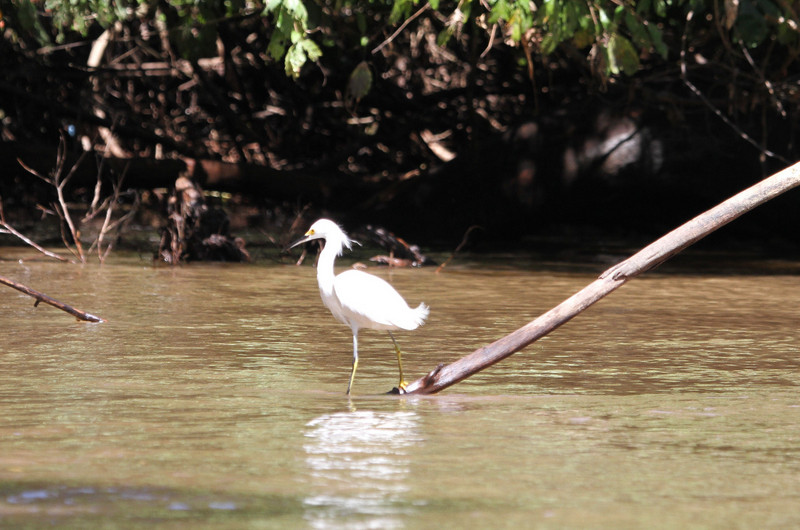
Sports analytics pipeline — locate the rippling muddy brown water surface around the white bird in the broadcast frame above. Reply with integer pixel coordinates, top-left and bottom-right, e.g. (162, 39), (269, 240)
(0, 249), (800, 529)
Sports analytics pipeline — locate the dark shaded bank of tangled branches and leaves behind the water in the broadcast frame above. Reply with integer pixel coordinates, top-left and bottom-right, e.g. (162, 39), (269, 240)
(0, 0), (800, 249)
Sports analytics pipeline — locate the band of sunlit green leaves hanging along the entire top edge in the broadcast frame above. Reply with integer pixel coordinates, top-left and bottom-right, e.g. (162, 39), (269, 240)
(6, 0), (800, 78)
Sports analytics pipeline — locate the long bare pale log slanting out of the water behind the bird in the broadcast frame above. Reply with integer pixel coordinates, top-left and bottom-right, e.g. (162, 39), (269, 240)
(404, 159), (800, 394)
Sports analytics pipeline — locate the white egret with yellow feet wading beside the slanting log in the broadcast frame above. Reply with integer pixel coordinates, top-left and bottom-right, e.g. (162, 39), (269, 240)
(289, 219), (429, 394)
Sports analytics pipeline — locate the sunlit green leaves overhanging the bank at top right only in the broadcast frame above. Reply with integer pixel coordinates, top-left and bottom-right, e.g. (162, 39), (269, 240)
(416, 0), (800, 76)
